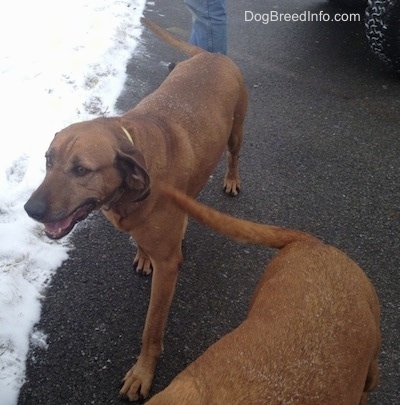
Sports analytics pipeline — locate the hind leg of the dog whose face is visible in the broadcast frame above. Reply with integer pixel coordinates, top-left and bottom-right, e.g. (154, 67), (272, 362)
(224, 88), (247, 195)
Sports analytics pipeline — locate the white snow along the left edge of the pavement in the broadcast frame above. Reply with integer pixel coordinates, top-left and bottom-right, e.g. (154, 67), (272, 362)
(0, 0), (145, 405)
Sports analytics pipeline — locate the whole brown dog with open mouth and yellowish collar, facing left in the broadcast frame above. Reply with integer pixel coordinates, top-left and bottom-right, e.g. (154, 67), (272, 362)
(25, 20), (247, 400)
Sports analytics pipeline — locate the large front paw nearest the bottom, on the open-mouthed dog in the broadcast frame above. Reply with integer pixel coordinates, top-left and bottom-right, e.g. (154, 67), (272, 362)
(119, 363), (153, 401)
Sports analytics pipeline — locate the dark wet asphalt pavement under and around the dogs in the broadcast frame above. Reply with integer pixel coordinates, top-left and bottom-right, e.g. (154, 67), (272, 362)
(19, 0), (400, 405)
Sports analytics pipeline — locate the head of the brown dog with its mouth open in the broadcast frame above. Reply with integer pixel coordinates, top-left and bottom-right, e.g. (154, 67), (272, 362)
(24, 118), (150, 239)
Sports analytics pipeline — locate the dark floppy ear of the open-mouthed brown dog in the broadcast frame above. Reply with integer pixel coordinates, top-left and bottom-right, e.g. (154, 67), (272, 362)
(115, 149), (150, 202)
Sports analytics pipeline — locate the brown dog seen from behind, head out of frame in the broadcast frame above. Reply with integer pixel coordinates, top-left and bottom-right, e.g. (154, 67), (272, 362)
(147, 189), (380, 405)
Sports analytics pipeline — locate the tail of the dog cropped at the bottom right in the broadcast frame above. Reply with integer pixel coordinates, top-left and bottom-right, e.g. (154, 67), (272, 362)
(162, 187), (319, 249)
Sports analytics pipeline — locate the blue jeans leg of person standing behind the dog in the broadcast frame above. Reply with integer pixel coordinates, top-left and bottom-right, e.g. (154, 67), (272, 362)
(184, 0), (227, 55)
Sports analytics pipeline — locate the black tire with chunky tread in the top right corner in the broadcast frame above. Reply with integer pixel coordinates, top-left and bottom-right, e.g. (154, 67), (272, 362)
(365, 0), (400, 72)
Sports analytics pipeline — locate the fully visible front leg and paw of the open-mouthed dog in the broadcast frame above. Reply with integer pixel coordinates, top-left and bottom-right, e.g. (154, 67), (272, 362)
(120, 252), (182, 401)
